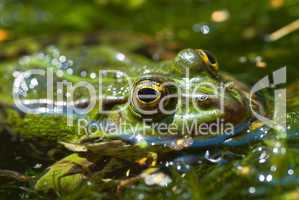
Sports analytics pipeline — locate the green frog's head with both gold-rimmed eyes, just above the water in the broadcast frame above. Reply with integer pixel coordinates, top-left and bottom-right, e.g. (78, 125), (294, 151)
(101, 49), (253, 138)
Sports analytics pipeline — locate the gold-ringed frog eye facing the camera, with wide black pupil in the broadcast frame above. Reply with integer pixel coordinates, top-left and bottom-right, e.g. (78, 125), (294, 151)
(130, 77), (176, 117)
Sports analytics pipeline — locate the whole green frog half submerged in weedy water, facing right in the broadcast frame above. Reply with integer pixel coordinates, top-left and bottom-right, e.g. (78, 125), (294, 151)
(1, 46), (262, 193)
